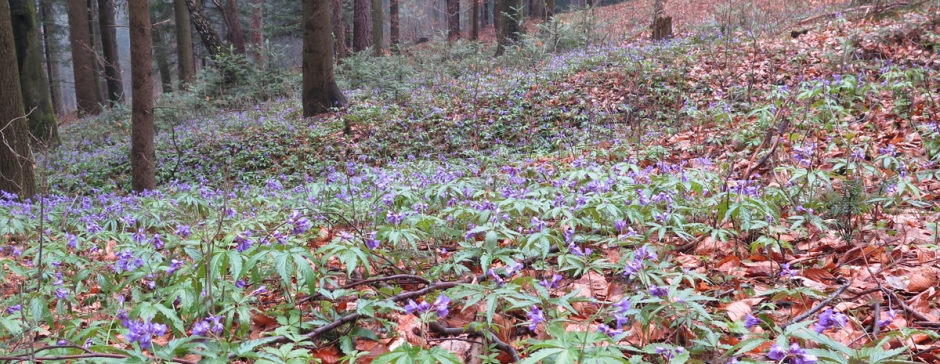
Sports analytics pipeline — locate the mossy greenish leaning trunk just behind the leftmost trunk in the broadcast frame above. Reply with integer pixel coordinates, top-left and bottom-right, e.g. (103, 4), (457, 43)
(8, 0), (59, 146)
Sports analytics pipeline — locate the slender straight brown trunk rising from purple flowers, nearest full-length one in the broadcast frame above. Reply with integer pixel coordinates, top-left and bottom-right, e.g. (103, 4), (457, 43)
(127, 0), (157, 192)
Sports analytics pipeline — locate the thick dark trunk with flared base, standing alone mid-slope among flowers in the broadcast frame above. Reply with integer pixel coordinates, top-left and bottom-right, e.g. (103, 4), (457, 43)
(303, 0), (346, 117)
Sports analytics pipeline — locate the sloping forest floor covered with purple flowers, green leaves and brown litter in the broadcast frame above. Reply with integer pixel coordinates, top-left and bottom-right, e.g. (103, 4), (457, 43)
(0, 1), (940, 363)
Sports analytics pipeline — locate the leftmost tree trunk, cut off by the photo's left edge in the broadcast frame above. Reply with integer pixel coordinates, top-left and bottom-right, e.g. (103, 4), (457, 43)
(0, 1), (36, 200)
